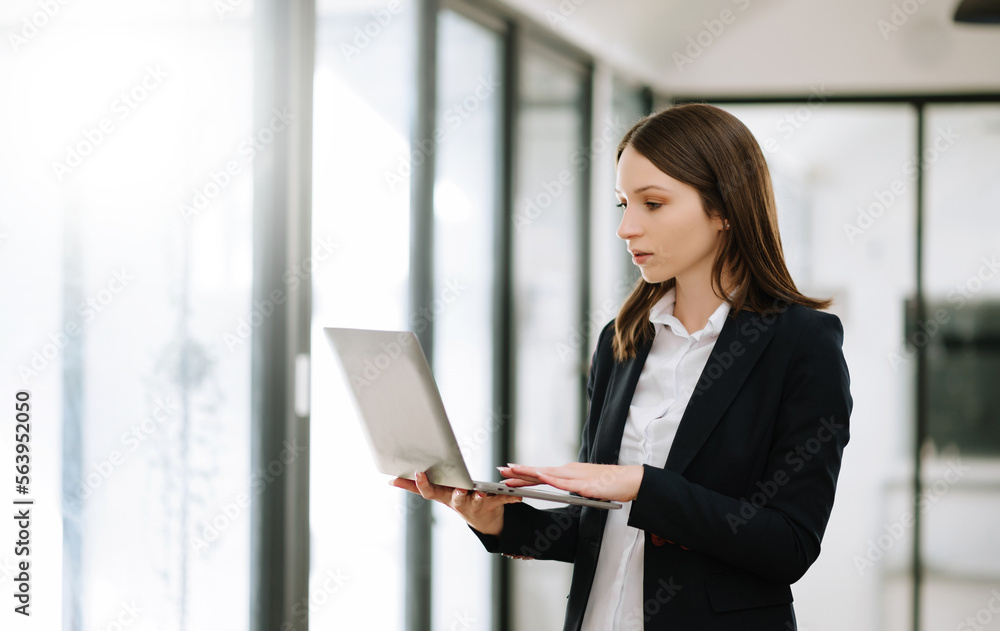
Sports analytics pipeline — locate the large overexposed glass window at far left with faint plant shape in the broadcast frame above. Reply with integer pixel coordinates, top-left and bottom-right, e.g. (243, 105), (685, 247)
(0, 1), (254, 629)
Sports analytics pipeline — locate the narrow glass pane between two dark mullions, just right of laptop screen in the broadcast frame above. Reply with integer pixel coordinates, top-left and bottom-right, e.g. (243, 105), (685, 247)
(428, 11), (509, 631)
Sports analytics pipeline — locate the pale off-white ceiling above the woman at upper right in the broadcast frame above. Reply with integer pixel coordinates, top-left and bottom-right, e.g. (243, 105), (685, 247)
(499, 0), (1000, 96)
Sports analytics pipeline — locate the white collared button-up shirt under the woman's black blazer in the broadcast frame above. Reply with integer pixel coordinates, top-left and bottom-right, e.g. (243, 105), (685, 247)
(583, 289), (730, 631)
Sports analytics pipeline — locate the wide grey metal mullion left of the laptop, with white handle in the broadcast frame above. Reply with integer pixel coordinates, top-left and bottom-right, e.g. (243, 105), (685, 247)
(250, 0), (316, 631)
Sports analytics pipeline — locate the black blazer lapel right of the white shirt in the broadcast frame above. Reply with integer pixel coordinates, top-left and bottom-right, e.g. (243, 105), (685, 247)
(668, 310), (781, 473)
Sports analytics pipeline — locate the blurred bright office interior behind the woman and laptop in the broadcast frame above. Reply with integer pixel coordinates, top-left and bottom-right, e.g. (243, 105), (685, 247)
(0, 0), (1000, 631)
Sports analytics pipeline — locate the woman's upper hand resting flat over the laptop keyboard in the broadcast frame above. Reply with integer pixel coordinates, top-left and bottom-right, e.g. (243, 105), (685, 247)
(497, 462), (643, 502)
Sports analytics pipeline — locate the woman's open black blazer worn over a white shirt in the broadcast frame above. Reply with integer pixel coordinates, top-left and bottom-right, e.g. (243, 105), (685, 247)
(473, 303), (853, 631)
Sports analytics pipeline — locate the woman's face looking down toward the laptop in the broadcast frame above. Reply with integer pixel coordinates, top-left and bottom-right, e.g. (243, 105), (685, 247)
(615, 145), (723, 283)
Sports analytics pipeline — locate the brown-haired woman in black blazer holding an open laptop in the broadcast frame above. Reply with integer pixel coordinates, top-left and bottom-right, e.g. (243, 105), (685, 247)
(393, 104), (853, 631)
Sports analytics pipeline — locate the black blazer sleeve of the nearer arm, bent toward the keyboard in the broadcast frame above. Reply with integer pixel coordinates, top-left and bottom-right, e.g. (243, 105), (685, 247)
(628, 311), (853, 584)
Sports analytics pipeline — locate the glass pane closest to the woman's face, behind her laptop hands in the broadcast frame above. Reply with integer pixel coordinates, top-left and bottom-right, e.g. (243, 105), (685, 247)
(512, 38), (589, 629)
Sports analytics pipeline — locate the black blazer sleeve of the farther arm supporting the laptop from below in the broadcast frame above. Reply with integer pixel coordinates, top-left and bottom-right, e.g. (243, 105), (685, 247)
(469, 320), (614, 563)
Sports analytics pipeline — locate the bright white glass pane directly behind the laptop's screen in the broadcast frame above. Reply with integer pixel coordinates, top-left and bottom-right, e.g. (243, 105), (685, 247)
(308, 2), (412, 629)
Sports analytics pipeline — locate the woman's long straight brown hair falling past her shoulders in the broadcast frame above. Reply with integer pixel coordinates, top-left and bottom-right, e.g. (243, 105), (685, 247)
(613, 103), (833, 362)
